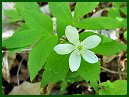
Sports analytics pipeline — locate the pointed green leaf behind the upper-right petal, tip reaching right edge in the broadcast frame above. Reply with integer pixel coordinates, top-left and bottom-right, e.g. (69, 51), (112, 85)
(80, 32), (127, 56)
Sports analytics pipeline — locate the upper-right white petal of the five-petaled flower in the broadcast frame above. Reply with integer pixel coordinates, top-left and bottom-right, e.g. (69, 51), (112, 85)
(83, 35), (101, 49)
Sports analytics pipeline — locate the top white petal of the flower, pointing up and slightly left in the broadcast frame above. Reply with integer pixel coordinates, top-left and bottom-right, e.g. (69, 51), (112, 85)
(65, 25), (79, 44)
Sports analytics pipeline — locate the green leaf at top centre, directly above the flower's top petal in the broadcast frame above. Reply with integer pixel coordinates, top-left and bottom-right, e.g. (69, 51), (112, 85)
(48, 2), (73, 38)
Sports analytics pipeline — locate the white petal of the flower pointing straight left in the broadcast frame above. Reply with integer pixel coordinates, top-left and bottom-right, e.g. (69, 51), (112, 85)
(54, 44), (74, 55)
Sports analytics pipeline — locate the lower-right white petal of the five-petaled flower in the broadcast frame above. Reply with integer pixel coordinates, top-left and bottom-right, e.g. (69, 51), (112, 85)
(82, 50), (98, 63)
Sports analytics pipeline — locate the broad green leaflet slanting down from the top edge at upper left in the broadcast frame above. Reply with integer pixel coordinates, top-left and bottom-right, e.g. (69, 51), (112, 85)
(15, 2), (53, 34)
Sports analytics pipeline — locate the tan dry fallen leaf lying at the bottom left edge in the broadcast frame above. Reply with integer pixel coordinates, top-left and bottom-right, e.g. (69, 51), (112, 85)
(9, 81), (40, 95)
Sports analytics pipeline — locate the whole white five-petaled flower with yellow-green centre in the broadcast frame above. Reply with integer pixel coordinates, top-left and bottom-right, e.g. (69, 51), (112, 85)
(54, 25), (101, 72)
